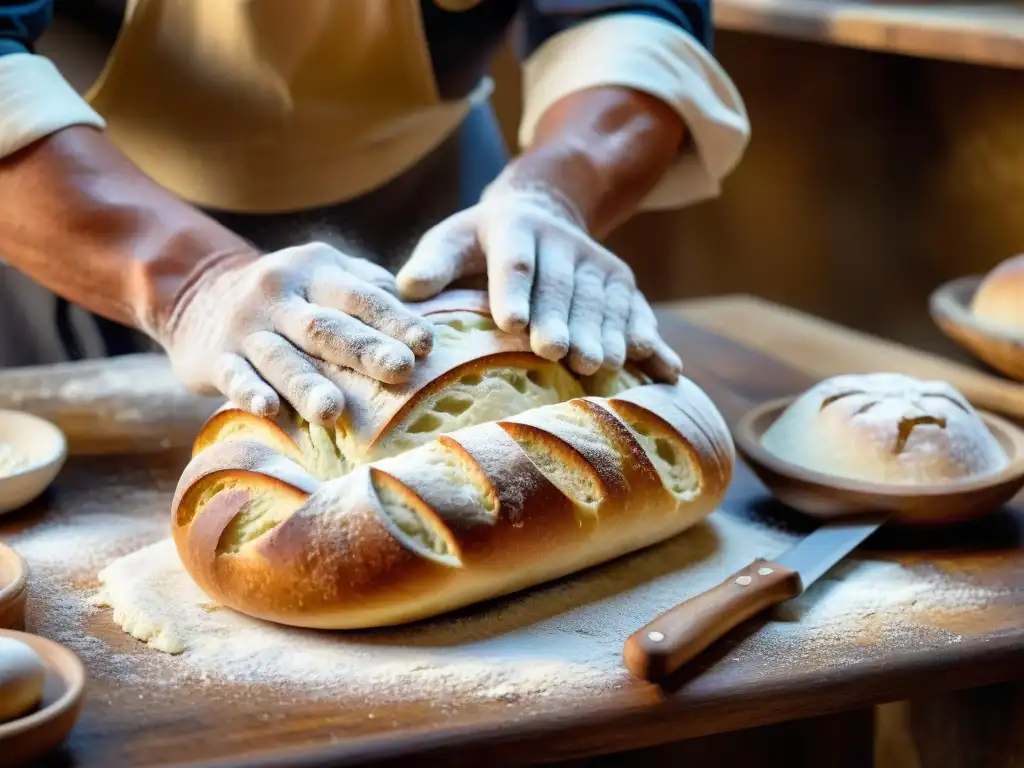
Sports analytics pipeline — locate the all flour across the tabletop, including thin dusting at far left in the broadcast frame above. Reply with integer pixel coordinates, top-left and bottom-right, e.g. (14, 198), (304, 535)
(7, 487), (999, 706)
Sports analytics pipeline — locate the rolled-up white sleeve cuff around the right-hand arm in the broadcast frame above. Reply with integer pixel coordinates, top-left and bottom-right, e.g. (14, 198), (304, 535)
(519, 13), (751, 210)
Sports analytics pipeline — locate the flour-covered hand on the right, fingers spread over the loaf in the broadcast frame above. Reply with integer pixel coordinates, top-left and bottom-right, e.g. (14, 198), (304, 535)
(397, 178), (682, 382)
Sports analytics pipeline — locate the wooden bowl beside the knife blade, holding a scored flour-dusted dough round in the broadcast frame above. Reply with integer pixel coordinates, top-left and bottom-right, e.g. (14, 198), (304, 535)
(733, 397), (1024, 525)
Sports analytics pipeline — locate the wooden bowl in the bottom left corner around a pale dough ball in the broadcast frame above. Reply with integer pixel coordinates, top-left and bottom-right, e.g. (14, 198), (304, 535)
(0, 630), (85, 765)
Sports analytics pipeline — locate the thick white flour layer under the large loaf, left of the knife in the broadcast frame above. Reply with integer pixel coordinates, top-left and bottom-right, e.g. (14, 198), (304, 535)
(93, 514), (787, 701)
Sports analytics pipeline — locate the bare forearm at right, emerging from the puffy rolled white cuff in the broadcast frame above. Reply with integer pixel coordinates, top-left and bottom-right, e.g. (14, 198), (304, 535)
(510, 86), (687, 238)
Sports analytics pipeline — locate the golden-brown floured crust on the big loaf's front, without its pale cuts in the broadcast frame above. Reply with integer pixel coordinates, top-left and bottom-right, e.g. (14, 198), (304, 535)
(174, 385), (732, 629)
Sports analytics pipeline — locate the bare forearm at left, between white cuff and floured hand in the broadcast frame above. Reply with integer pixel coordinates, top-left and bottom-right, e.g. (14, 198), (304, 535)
(0, 126), (255, 335)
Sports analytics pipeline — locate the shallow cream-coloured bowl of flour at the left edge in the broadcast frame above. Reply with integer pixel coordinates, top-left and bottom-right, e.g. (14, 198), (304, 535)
(0, 411), (68, 514)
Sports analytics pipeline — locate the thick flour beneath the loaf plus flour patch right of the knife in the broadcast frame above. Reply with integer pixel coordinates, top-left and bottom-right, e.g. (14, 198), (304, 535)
(81, 512), (997, 701)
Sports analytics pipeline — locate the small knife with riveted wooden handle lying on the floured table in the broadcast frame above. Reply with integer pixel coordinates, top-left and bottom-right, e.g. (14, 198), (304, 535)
(623, 514), (888, 681)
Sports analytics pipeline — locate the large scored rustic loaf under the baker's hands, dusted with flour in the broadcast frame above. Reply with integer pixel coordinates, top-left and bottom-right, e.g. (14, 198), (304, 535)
(172, 294), (734, 629)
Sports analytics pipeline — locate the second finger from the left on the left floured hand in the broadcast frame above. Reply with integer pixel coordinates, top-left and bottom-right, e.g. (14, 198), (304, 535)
(242, 331), (345, 426)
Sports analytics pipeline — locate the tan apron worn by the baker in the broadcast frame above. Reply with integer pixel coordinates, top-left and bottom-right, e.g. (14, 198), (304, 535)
(87, 0), (473, 213)
